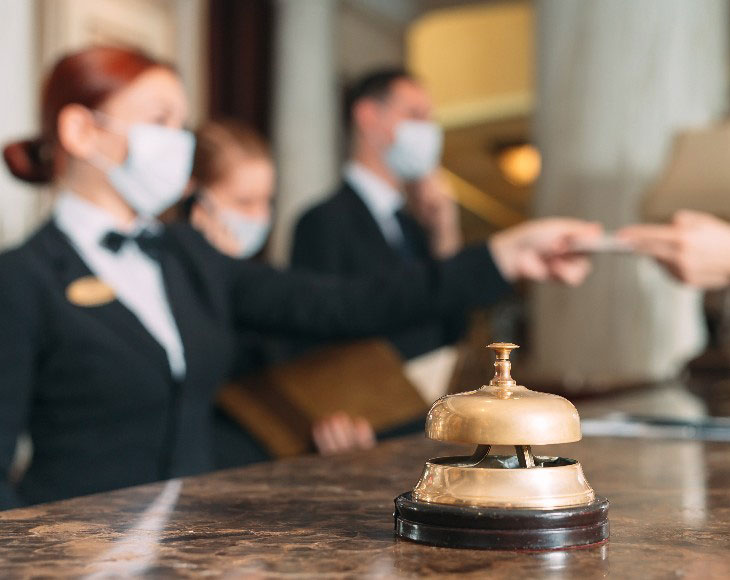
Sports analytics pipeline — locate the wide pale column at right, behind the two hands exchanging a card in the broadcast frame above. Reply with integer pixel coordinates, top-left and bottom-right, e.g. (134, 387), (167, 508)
(530, 0), (728, 390)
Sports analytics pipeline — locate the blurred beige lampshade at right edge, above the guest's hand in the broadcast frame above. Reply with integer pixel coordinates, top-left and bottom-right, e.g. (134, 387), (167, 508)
(643, 122), (730, 222)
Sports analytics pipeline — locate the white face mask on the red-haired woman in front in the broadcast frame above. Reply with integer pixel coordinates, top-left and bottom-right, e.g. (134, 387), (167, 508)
(91, 114), (195, 217)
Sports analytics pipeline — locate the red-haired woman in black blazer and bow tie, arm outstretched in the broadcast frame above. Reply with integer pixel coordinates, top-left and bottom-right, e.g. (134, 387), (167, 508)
(0, 48), (592, 507)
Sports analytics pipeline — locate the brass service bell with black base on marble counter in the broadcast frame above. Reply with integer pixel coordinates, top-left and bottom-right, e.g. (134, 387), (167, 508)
(395, 342), (608, 550)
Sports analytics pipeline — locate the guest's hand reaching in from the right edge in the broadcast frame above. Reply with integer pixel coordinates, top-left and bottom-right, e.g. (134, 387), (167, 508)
(617, 210), (730, 289)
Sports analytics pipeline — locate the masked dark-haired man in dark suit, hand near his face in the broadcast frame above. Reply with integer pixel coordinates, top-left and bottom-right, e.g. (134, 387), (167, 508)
(292, 69), (463, 358)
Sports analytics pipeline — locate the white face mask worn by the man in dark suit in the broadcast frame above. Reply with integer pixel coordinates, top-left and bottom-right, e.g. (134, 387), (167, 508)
(385, 120), (444, 181)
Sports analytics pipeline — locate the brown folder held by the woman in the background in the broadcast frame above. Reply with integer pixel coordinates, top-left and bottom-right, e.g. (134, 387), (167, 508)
(218, 340), (428, 457)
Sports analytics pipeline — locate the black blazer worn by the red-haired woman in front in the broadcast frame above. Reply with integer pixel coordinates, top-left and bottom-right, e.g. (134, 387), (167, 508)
(0, 222), (509, 507)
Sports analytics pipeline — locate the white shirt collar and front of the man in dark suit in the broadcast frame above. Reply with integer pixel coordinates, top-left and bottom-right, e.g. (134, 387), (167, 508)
(344, 161), (405, 247)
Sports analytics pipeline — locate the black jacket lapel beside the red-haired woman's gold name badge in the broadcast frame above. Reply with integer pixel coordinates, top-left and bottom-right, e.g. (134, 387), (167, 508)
(40, 222), (171, 377)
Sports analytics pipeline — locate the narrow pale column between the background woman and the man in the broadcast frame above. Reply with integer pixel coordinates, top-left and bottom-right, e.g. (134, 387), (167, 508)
(271, 0), (340, 264)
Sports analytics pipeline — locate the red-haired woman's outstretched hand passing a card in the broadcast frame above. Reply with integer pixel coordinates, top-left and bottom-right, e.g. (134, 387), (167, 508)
(489, 218), (603, 286)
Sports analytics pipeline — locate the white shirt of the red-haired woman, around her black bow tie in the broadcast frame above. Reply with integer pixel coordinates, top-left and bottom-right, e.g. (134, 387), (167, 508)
(53, 192), (186, 379)
